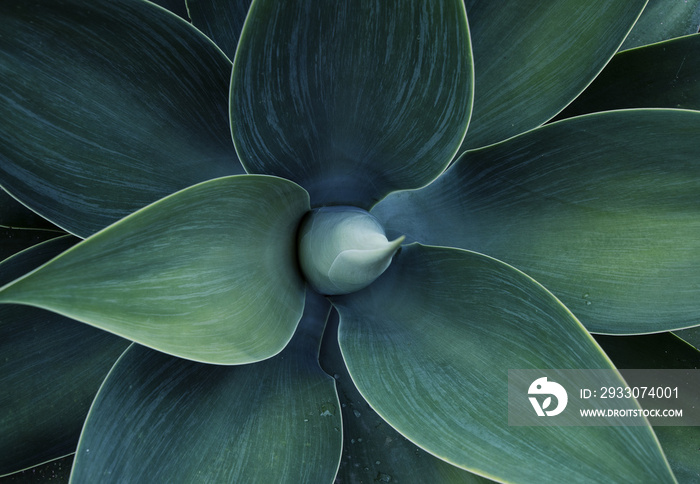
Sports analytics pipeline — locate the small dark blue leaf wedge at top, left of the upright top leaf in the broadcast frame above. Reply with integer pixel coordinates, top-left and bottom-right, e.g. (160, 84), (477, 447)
(183, 0), (252, 59)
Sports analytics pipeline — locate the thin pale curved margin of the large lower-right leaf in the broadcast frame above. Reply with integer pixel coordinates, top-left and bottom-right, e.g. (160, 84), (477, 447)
(329, 242), (675, 484)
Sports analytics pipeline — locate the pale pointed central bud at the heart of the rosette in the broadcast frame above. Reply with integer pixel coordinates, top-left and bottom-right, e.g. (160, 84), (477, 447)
(299, 206), (405, 295)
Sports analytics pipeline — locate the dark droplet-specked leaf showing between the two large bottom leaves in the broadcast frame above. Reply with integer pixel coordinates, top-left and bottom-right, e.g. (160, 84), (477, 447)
(320, 311), (492, 484)
